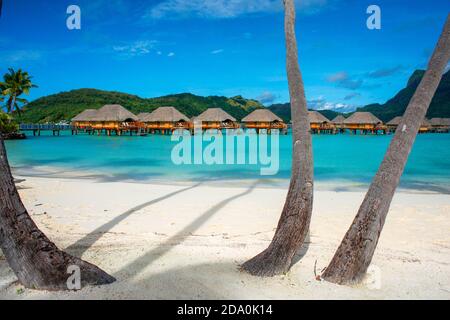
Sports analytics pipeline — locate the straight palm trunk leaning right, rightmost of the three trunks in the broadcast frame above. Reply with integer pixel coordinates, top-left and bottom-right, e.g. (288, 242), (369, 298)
(322, 15), (450, 284)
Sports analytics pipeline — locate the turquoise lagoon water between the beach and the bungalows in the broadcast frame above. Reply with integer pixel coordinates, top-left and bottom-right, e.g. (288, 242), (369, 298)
(6, 133), (450, 193)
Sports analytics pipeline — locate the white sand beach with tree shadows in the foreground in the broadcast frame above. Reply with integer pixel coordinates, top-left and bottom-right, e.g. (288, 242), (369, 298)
(0, 177), (450, 299)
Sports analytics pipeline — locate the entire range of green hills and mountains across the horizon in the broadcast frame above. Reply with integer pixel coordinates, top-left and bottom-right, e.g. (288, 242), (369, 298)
(15, 70), (450, 123)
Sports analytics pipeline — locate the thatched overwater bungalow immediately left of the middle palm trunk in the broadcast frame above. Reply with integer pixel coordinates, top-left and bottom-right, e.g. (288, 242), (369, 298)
(242, 109), (287, 133)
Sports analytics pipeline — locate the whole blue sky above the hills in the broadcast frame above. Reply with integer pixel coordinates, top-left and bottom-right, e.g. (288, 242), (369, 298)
(0, 0), (450, 111)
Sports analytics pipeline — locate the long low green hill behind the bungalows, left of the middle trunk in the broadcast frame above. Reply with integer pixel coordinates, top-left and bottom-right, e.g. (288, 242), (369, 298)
(15, 89), (264, 123)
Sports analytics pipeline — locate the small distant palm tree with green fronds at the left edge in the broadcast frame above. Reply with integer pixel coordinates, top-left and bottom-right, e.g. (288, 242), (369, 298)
(0, 68), (37, 113)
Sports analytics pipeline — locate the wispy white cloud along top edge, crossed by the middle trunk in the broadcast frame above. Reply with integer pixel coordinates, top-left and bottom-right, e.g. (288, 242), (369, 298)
(146, 0), (333, 19)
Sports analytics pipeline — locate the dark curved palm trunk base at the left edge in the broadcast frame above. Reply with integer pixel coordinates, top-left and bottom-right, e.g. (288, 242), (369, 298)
(0, 138), (115, 290)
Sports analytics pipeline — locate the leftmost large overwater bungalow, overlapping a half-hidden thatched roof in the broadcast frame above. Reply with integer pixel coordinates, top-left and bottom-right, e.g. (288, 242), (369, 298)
(89, 104), (140, 135)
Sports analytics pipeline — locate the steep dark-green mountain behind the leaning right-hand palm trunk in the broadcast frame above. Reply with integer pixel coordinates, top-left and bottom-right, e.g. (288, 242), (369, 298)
(357, 70), (450, 122)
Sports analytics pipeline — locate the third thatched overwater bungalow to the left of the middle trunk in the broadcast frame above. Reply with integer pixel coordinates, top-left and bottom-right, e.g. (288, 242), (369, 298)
(139, 107), (190, 134)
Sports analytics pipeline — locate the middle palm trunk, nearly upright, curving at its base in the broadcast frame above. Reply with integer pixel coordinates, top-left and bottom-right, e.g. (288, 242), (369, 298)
(242, 0), (313, 276)
